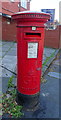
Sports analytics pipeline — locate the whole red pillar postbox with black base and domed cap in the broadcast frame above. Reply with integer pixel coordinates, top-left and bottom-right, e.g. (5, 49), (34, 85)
(12, 11), (50, 106)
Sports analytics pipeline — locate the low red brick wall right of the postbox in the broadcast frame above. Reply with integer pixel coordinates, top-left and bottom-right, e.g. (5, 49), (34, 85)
(44, 26), (61, 48)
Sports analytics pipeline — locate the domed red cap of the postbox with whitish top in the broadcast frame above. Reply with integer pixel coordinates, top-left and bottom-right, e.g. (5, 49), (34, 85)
(12, 11), (50, 23)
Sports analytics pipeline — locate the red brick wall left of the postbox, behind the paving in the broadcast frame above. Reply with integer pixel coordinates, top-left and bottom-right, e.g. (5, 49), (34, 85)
(2, 17), (16, 41)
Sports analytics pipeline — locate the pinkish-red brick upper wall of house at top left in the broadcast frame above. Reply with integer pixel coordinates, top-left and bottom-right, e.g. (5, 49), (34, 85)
(0, 0), (30, 15)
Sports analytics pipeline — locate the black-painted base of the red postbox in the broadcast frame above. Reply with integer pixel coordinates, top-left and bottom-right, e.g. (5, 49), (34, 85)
(16, 90), (40, 110)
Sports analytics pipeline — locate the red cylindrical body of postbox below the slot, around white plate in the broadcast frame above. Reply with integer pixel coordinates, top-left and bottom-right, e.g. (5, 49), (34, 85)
(18, 28), (43, 95)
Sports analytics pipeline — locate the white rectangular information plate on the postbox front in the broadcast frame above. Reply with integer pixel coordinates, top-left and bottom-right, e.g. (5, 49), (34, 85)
(28, 42), (38, 58)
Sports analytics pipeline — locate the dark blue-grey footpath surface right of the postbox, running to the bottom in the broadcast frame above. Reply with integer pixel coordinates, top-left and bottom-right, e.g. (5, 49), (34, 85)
(21, 51), (61, 118)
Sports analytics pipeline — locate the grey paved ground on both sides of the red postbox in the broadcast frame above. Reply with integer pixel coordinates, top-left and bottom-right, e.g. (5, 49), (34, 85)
(0, 41), (61, 118)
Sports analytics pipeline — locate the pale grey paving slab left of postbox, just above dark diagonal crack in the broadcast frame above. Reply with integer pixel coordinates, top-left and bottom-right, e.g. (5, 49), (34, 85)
(2, 55), (17, 72)
